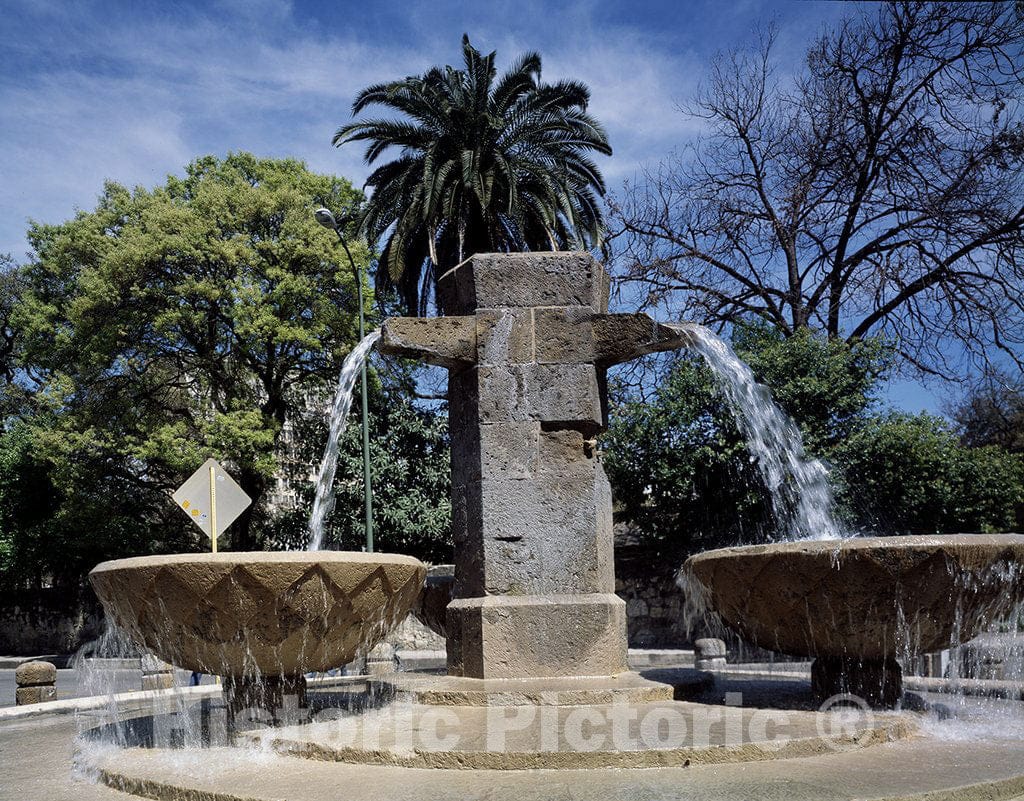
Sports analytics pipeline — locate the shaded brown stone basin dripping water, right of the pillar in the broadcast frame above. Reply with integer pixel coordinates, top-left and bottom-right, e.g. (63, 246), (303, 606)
(681, 535), (1024, 695)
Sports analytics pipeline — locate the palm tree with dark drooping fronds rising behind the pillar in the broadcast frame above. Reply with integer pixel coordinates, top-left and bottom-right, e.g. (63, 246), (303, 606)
(333, 36), (611, 313)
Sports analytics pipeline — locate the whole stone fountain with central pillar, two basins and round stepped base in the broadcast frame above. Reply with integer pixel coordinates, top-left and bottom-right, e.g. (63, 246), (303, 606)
(77, 253), (1024, 799)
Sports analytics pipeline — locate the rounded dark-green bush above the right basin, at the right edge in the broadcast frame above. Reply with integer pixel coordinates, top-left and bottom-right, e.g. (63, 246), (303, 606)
(835, 413), (1024, 534)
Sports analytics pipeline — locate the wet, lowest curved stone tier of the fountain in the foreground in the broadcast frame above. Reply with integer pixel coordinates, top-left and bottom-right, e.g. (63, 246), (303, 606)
(90, 740), (1024, 801)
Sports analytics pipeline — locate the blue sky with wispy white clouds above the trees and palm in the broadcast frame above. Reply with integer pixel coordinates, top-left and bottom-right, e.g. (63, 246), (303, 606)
(0, 0), (939, 411)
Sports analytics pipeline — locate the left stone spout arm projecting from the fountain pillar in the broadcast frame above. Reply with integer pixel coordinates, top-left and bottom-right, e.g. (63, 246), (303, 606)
(378, 317), (476, 369)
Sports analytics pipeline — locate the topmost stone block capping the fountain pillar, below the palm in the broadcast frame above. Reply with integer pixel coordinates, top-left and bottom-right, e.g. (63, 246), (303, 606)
(456, 251), (609, 314)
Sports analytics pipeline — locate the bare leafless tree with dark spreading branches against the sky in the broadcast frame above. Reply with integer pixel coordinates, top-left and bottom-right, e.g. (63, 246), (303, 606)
(611, 2), (1024, 377)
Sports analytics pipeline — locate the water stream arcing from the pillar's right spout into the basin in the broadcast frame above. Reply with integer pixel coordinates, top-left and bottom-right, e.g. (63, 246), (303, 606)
(672, 324), (849, 540)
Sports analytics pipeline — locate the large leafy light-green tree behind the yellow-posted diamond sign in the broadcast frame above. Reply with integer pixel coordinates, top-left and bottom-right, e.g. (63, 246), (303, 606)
(11, 154), (367, 552)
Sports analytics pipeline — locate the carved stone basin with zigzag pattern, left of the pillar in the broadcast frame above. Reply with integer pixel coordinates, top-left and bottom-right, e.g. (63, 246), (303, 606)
(89, 551), (426, 678)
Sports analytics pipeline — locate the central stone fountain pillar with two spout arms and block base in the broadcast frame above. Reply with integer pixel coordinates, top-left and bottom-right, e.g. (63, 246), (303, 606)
(380, 253), (685, 679)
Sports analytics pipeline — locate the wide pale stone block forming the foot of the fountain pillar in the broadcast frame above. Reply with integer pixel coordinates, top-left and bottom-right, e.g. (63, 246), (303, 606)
(447, 593), (628, 678)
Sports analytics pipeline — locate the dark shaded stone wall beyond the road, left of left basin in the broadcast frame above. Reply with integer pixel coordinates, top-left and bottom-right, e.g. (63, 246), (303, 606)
(0, 589), (102, 657)
